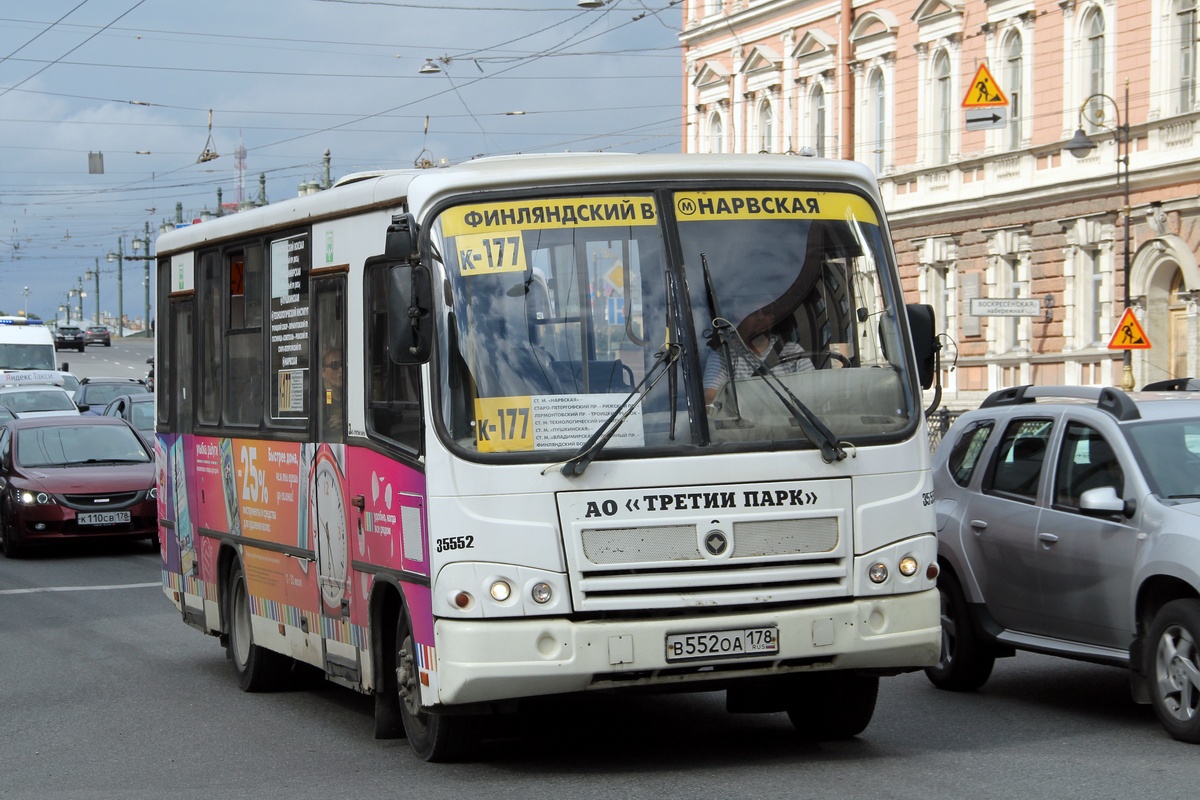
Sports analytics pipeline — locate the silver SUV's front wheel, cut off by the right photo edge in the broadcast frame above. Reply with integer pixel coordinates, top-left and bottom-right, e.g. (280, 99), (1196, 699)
(1146, 600), (1200, 744)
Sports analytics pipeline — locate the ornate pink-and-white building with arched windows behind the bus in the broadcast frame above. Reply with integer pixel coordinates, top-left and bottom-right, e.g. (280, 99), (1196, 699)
(680, 0), (1200, 408)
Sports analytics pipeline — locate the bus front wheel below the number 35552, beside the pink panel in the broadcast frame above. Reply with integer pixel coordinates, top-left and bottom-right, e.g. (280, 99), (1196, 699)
(396, 612), (479, 762)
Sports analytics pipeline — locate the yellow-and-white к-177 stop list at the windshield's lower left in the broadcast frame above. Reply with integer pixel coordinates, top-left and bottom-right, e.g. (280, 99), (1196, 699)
(475, 393), (646, 452)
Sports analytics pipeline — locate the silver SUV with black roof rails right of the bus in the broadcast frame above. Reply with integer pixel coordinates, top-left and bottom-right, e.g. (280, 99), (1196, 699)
(925, 386), (1200, 742)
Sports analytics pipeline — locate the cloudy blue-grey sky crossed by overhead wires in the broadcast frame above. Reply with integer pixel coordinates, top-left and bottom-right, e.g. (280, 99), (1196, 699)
(0, 0), (683, 320)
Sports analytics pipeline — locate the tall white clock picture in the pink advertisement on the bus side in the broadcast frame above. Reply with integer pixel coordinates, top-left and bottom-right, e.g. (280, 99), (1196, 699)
(308, 445), (350, 616)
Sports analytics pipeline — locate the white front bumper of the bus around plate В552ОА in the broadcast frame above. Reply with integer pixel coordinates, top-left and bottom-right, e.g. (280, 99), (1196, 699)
(422, 589), (942, 705)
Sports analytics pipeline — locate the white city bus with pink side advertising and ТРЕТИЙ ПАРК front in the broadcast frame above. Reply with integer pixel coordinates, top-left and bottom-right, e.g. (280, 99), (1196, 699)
(157, 155), (941, 760)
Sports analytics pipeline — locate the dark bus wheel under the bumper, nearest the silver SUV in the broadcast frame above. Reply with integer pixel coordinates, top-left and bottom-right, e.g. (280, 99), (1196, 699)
(787, 672), (880, 741)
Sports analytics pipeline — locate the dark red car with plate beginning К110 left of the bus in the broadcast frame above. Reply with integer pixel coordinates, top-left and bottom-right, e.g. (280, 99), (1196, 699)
(0, 416), (158, 558)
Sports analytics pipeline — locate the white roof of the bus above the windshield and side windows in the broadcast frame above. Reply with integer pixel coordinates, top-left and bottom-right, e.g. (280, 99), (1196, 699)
(157, 152), (882, 255)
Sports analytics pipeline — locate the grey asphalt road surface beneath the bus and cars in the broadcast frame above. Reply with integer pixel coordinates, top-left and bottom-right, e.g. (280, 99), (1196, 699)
(0, 342), (1200, 800)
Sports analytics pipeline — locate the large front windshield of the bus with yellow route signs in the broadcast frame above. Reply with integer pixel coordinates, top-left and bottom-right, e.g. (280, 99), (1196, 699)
(432, 188), (916, 458)
